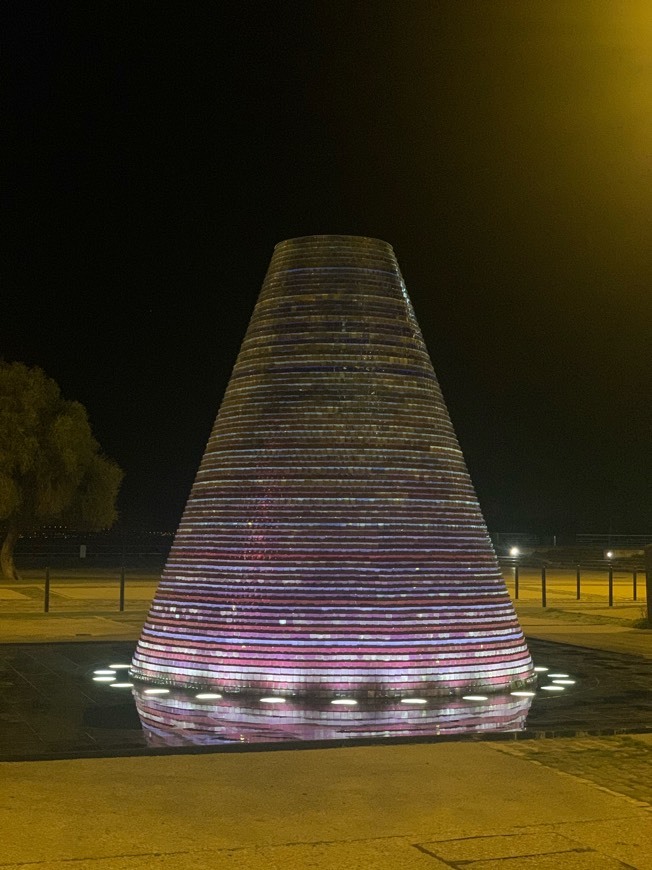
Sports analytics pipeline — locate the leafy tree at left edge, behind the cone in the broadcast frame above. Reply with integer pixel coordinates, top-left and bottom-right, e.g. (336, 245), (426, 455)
(0, 360), (123, 580)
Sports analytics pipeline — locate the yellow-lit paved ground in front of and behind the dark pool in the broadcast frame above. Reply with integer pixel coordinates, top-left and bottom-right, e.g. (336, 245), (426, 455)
(0, 576), (652, 870)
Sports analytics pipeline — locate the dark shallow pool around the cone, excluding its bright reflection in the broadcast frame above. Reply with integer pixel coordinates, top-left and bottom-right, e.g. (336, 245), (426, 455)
(0, 639), (652, 760)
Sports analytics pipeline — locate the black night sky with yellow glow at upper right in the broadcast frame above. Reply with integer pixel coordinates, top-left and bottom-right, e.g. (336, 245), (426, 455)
(5, 0), (652, 533)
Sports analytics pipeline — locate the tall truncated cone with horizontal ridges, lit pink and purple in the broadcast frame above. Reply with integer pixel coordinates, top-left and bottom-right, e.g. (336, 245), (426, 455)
(132, 236), (533, 699)
